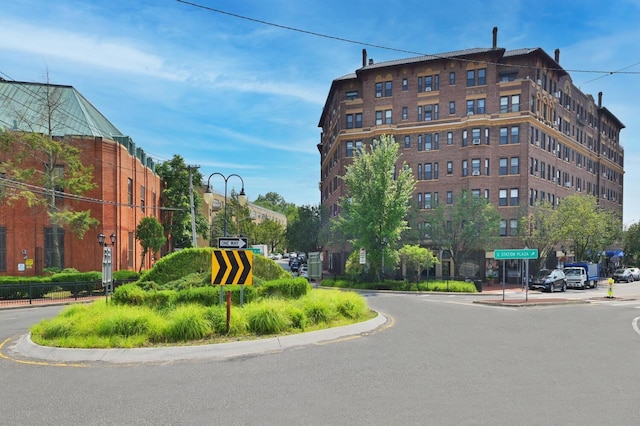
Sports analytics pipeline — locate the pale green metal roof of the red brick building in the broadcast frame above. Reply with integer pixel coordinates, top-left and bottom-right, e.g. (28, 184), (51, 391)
(0, 80), (124, 140)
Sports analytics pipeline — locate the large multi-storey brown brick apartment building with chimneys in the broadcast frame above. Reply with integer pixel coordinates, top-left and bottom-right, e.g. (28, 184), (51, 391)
(318, 28), (624, 275)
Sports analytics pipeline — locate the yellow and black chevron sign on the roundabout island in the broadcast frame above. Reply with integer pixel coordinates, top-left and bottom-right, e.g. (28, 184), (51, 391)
(211, 250), (253, 285)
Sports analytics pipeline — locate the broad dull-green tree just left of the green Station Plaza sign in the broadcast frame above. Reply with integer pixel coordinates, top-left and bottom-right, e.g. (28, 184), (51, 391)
(425, 190), (500, 275)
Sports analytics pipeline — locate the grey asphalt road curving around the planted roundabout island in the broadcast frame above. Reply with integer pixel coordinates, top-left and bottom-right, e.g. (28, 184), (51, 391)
(0, 283), (640, 425)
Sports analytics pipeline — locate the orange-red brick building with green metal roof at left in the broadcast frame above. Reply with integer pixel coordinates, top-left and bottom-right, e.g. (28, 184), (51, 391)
(0, 80), (161, 276)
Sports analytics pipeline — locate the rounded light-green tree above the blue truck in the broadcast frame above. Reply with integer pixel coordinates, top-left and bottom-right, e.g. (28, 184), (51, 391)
(553, 195), (622, 261)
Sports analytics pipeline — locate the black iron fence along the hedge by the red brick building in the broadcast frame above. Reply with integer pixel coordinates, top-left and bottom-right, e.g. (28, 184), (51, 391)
(0, 280), (131, 307)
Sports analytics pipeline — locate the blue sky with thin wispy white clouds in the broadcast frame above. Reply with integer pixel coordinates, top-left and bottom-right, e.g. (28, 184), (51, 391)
(0, 0), (640, 226)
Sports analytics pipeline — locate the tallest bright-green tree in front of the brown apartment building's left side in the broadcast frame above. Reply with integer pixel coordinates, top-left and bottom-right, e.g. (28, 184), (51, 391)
(333, 135), (415, 278)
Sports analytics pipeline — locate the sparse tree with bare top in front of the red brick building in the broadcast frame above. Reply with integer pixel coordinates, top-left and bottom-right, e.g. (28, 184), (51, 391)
(0, 84), (99, 268)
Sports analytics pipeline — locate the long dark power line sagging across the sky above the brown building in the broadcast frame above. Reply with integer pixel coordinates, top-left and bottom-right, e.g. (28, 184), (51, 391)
(176, 0), (640, 77)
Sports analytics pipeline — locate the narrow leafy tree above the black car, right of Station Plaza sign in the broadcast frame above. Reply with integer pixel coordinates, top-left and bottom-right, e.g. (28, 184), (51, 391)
(519, 201), (559, 269)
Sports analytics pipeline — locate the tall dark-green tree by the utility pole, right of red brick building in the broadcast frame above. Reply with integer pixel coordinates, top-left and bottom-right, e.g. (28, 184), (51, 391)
(156, 155), (210, 251)
